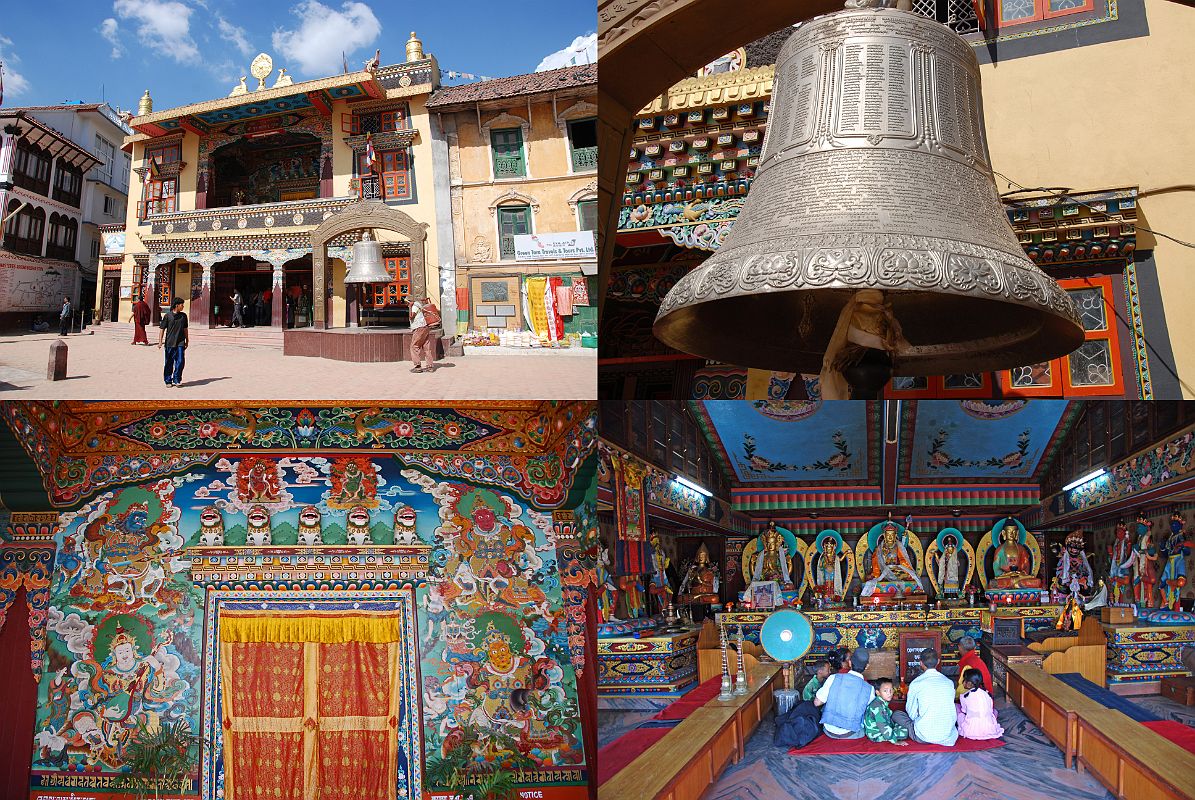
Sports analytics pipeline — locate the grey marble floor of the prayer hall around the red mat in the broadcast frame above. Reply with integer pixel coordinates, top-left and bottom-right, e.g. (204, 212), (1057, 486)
(598, 696), (1195, 800)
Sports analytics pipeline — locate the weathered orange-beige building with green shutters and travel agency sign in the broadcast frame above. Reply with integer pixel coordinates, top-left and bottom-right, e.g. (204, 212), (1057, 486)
(427, 65), (598, 338)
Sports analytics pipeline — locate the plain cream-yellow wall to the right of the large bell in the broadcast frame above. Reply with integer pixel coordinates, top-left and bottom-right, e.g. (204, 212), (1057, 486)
(981, 0), (1195, 398)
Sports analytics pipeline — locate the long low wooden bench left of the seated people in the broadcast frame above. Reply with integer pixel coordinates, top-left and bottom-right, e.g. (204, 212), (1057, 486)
(598, 664), (780, 800)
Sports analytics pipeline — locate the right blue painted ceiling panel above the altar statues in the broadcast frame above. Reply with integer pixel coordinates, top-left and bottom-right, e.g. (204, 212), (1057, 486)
(901, 399), (1067, 481)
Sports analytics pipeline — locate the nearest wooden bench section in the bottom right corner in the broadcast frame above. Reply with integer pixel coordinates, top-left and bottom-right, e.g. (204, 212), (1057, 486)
(1076, 708), (1195, 800)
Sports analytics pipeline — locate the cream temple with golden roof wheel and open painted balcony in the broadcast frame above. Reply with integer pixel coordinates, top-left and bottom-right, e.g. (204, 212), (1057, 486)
(120, 33), (442, 358)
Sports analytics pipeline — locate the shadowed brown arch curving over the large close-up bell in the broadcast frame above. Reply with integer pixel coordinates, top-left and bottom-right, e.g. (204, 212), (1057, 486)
(598, 0), (842, 309)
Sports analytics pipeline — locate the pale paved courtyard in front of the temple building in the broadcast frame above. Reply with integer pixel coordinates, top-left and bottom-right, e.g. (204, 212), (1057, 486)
(0, 334), (598, 399)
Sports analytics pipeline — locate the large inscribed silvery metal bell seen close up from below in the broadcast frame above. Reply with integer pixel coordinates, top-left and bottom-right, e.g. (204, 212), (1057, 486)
(654, 8), (1083, 387)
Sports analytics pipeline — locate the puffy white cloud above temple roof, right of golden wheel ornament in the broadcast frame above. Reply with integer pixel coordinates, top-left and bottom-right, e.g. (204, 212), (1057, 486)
(274, 0), (381, 78)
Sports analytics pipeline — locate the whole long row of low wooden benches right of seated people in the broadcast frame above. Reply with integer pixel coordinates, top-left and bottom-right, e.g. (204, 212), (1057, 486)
(1009, 664), (1195, 800)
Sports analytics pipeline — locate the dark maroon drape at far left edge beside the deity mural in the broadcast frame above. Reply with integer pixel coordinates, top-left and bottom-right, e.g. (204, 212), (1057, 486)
(0, 588), (37, 798)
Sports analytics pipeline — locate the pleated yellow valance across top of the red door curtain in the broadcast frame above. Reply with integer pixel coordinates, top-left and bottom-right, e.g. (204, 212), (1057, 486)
(220, 611), (402, 645)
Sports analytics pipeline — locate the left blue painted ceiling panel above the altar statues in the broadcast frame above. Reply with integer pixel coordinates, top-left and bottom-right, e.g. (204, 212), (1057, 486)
(703, 401), (869, 483)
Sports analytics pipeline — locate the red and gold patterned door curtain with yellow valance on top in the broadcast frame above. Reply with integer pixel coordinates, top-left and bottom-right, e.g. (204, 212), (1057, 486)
(220, 611), (405, 800)
